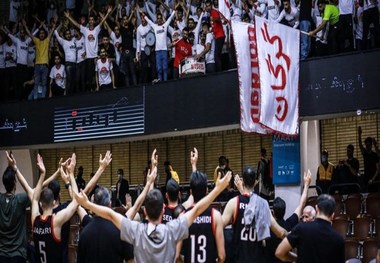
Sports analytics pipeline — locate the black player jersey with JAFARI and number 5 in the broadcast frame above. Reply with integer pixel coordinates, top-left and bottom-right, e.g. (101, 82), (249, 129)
(33, 215), (62, 263)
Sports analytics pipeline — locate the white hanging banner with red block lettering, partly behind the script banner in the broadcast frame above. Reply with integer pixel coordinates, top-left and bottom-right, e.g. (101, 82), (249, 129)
(232, 20), (267, 134)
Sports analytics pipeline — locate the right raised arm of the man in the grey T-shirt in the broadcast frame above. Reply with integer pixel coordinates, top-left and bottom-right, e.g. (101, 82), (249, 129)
(184, 171), (232, 226)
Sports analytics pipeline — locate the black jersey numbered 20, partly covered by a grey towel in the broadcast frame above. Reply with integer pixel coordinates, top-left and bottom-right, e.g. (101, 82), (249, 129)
(232, 195), (265, 263)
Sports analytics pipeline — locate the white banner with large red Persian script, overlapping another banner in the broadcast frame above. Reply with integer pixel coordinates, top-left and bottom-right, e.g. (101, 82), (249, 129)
(255, 16), (300, 135)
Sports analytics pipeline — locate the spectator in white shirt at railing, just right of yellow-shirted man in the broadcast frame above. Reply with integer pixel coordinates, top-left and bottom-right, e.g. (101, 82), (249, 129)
(49, 55), (66, 98)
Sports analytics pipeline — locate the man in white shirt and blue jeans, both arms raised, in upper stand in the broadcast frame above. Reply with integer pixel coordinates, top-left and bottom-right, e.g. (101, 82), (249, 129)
(141, 11), (176, 81)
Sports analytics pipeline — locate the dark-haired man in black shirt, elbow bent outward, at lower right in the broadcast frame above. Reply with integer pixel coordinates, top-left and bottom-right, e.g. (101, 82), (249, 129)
(276, 194), (345, 263)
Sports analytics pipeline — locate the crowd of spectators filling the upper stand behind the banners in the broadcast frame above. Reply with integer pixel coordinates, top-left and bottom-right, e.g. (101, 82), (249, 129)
(0, 0), (380, 100)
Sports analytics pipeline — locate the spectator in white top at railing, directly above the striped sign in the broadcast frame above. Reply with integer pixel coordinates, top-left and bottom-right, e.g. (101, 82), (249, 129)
(95, 48), (116, 91)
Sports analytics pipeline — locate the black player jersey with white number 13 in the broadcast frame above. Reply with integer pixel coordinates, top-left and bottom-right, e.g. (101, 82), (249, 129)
(183, 207), (218, 263)
